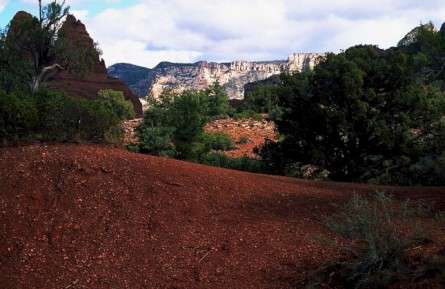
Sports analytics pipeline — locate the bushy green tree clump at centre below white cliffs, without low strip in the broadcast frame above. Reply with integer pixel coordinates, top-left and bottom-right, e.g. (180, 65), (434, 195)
(138, 83), (229, 160)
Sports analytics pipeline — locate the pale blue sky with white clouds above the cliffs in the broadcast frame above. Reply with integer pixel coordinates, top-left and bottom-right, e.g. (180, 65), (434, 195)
(0, 0), (445, 67)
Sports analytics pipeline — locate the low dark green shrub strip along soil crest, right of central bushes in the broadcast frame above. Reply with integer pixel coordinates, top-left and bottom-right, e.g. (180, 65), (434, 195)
(200, 152), (268, 173)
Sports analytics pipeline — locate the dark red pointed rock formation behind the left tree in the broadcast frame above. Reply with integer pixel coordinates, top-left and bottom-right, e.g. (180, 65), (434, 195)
(48, 15), (142, 116)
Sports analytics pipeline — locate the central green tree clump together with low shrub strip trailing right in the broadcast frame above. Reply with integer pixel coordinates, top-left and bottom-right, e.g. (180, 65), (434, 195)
(137, 84), (267, 172)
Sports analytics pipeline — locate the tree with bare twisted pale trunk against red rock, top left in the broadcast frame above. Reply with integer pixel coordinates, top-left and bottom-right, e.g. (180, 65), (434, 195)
(0, 1), (99, 93)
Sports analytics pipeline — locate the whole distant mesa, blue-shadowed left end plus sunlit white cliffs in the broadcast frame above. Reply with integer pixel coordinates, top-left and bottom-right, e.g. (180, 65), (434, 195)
(108, 53), (325, 99)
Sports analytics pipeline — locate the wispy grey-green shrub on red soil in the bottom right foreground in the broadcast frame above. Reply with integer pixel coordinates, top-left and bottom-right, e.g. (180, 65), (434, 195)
(311, 193), (442, 289)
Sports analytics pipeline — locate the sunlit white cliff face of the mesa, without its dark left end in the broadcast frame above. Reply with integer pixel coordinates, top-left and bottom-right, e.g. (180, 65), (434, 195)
(148, 53), (324, 99)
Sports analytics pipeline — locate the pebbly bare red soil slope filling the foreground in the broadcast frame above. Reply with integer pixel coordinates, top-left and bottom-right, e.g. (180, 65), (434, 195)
(0, 145), (445, 289)
